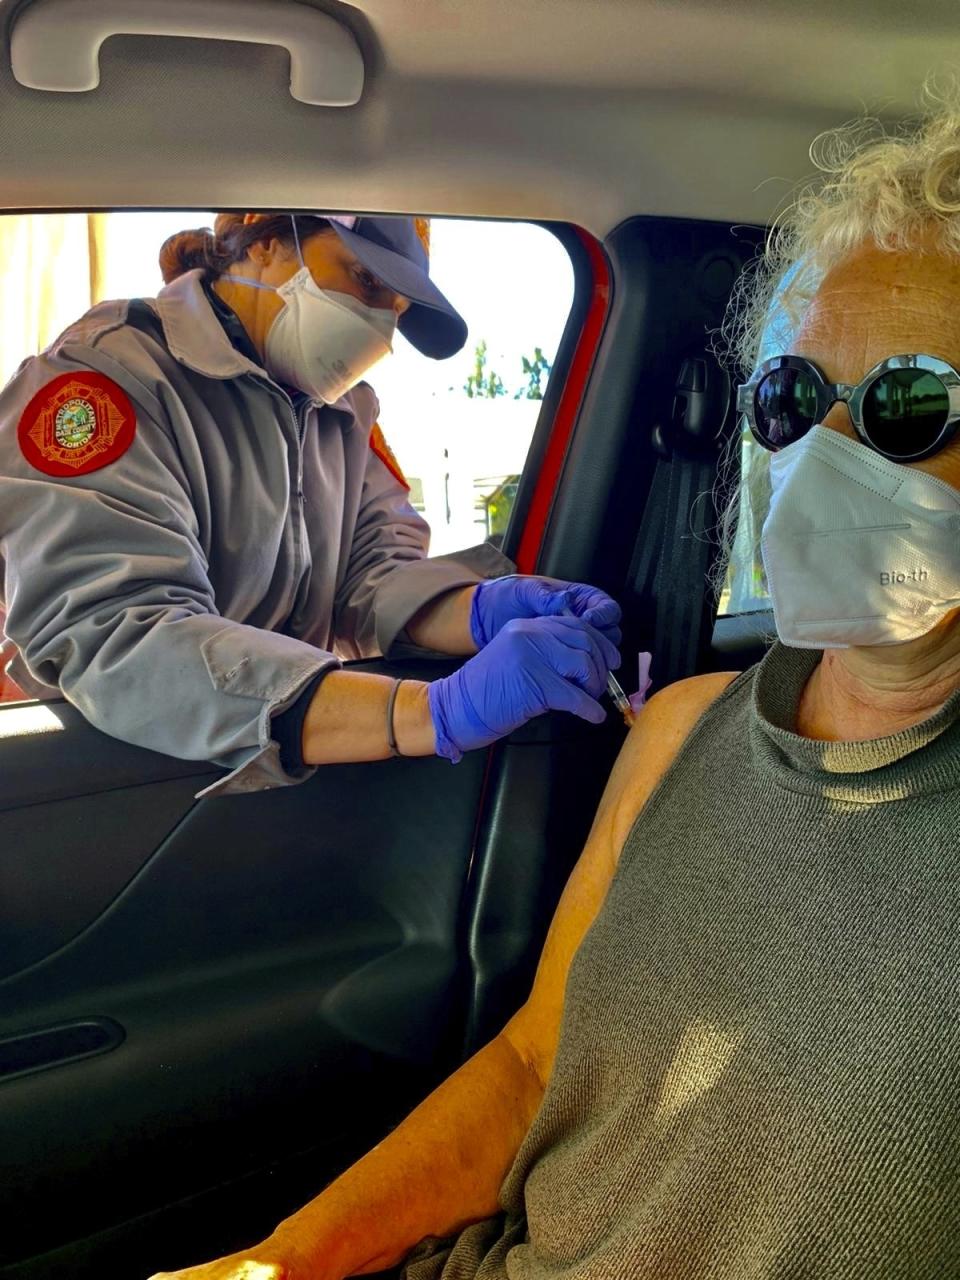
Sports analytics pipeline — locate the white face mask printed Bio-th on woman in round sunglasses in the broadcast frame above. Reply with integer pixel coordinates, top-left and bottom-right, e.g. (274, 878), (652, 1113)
(760, 426), (960, 649)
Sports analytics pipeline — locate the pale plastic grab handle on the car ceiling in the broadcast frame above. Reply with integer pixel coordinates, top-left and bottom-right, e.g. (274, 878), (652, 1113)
(10, 0), (364, 106)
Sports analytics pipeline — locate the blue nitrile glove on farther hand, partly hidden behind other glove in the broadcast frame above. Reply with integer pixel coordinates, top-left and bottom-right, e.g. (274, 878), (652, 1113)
(470, 573), (621, 649)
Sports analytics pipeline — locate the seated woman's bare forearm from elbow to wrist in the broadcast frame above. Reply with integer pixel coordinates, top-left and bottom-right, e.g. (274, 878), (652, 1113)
(275, 1036), (543, 1280)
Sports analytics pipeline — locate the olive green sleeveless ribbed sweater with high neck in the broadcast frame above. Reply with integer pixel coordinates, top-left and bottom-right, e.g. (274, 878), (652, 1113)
(403, 645), (960, 1280)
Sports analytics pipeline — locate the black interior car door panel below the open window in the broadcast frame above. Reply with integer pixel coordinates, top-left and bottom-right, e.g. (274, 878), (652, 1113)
(0, 663), (485, 1277)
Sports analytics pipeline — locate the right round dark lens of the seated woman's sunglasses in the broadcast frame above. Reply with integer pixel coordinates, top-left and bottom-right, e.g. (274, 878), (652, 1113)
(861, 369), (950, 458)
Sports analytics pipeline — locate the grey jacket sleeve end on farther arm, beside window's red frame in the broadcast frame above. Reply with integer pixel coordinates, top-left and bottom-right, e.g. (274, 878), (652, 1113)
(374, 543), (517, 654)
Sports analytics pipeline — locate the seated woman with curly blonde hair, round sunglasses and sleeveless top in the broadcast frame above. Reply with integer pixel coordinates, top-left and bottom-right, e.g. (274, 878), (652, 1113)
(154, 87), (960, 1280)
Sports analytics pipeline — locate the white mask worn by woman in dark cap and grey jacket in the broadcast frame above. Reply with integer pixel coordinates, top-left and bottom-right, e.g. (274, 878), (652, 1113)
(263, 266), (397, 404)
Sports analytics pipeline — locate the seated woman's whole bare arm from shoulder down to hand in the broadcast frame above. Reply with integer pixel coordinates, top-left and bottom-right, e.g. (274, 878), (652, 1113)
(146, 673), (733, 1280)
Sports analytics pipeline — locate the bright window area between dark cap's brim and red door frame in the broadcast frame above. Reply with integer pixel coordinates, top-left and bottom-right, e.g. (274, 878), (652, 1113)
(370, 219), (573, 556)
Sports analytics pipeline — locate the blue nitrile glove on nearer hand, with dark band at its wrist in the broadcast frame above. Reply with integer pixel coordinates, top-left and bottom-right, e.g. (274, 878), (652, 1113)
(428, 617), (620, 763)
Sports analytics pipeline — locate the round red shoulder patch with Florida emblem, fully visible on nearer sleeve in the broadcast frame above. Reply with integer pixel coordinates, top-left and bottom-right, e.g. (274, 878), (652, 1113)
(17, 370), (137, 476)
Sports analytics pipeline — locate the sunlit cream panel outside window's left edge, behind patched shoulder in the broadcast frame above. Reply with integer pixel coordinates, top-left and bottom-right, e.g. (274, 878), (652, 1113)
(0, 214), (108, 385)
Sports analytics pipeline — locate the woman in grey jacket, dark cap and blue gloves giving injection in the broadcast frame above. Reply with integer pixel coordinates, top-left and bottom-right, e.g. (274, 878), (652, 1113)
(0, 214), (620, 794)
